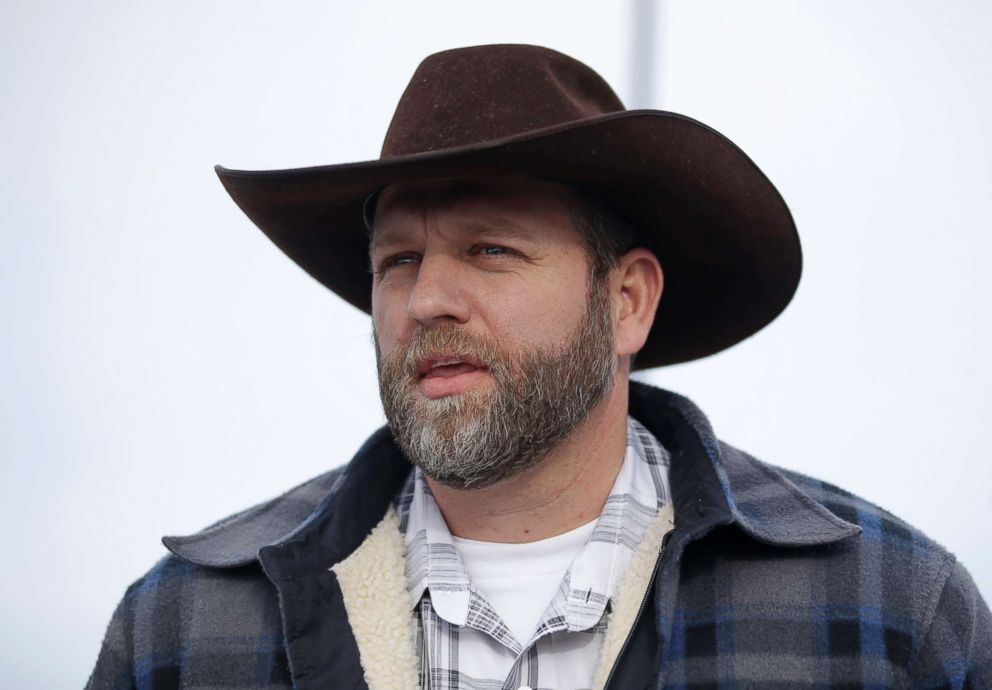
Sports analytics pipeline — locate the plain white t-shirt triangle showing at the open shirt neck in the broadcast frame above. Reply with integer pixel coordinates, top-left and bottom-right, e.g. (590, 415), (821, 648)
(451, 517), (599, 644)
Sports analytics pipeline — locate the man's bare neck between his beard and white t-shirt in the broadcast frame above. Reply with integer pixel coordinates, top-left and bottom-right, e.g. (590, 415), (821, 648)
(427, 372), (627, 543)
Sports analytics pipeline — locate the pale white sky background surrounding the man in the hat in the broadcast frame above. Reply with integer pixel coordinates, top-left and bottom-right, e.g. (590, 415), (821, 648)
(0, 0), (992, 688)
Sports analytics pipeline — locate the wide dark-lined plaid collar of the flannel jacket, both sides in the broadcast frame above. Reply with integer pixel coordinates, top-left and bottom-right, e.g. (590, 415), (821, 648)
(162, 382), (861, 575)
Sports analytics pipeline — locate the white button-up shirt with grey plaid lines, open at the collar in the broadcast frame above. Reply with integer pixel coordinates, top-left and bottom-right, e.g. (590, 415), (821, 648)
(396, 418), (670, 690)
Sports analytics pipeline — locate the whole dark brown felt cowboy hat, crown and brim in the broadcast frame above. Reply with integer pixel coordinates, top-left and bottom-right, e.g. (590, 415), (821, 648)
(217, 45), (802, 368)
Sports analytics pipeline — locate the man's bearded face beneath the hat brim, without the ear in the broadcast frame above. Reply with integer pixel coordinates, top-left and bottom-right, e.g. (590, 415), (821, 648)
(370, 178), (617, 488)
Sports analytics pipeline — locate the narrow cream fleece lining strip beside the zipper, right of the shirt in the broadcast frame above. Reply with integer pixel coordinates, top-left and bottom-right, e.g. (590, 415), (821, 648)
(592, 503), (675, 690)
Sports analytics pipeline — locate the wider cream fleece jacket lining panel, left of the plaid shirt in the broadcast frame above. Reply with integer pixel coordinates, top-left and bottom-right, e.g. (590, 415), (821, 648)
(331, 507), (420, 690)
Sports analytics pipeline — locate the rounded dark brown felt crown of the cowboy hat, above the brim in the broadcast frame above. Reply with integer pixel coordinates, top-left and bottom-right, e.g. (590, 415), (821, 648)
(381, 45), (624, 158)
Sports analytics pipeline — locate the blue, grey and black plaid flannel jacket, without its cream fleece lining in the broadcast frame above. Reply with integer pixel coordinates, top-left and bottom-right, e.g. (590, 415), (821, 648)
(88, 384), (992, 690)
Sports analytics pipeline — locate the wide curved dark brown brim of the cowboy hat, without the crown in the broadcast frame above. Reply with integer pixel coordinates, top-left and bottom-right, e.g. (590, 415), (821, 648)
(216, 110), (802, 369)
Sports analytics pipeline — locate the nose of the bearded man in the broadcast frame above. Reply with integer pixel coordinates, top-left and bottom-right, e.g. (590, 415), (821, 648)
(407, 254), (469, 326)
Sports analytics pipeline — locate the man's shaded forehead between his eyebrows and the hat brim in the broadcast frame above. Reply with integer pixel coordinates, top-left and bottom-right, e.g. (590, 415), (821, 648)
(372, 177), (575, 238)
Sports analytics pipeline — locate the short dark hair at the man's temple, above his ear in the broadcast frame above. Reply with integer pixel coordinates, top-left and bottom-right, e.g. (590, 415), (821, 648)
(571, 187), (644, 282)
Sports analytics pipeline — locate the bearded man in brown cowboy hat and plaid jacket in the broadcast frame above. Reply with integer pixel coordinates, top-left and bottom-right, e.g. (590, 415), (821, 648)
(90, 46), (992, 689)
